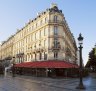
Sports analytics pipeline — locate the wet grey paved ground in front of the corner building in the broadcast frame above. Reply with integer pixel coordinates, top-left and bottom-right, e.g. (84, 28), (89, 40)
(0, 75), (96, 91)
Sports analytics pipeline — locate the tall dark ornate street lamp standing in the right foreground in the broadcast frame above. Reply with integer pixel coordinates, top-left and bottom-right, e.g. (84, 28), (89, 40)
(76, 33), (85, 89)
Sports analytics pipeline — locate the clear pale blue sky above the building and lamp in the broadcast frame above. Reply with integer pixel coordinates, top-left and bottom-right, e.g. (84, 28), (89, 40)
(0, 0), (96, 64)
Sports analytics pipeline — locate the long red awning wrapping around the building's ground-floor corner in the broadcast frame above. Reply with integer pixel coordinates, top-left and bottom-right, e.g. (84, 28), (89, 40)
(15, 61), (79, 68)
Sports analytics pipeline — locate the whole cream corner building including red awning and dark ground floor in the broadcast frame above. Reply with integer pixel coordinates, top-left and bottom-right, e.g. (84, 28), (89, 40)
(0, 4), (78, 77)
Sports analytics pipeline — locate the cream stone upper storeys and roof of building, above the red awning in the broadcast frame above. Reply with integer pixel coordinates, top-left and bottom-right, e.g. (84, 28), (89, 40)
(0, 5), (77, 63)
